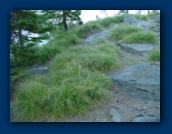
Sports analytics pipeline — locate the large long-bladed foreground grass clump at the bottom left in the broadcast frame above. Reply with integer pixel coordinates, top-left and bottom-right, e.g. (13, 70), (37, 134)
(11, 66), (111, 121)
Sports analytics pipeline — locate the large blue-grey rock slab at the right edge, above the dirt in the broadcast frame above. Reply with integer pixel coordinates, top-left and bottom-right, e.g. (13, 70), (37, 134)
(108, 62), (160, 101)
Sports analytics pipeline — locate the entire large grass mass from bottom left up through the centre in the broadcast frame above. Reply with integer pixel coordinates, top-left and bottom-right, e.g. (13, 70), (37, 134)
(11, 43), (120, 121)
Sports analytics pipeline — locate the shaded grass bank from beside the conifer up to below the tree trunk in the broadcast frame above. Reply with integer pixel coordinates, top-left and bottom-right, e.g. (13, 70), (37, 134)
(10, 30), (80, 83)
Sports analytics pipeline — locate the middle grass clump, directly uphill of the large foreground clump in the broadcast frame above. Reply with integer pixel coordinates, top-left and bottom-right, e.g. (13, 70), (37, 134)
(51, 43), (119, 72)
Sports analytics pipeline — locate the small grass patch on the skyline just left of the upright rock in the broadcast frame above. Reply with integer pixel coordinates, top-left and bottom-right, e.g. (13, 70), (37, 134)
(97, 15), (124, 27)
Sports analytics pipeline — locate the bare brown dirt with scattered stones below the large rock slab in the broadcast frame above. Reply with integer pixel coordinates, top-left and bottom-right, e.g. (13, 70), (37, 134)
(61, 89), (160, 122)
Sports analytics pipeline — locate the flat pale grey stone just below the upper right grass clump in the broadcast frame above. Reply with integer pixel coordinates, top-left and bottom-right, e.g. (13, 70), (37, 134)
(120, 43), (154, 55)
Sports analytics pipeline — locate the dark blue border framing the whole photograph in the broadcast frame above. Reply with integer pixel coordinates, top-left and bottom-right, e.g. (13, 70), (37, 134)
(0, 0), (172, 134)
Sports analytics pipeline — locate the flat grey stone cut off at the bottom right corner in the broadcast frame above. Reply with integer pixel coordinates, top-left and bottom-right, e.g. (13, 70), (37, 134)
(132, 117), (160, 122)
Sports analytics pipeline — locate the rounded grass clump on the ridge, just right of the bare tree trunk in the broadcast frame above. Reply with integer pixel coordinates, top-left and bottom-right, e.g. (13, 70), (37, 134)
(73, 21), (103, 37)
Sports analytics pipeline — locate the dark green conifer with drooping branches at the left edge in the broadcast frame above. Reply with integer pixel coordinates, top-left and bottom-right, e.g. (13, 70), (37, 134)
(10, 10), (53, 67)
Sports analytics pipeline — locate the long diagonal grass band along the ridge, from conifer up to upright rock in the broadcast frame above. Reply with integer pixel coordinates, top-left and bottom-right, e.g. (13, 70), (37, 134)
(10, 16), (123, 89)
